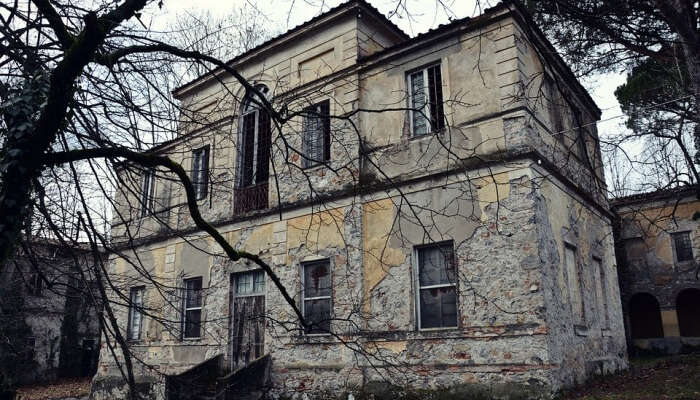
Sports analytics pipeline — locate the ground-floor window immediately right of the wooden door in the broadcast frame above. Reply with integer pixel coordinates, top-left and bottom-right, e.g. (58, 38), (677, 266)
(302, 260), (332, 334)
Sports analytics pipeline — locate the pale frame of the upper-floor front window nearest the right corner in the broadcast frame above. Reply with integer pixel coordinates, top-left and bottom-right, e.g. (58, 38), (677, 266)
(406, 60), (445, 138)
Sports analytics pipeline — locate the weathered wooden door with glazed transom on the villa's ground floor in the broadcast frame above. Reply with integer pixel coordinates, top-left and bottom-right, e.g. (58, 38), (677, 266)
(229, 271), (265, 371)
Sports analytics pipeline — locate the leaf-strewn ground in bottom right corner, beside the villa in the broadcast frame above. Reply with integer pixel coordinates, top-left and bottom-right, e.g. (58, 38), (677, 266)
(559, 354), (700, 400)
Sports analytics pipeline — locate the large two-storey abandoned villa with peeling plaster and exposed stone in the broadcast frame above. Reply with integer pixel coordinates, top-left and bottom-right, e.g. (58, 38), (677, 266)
(92, 0), (627, 398)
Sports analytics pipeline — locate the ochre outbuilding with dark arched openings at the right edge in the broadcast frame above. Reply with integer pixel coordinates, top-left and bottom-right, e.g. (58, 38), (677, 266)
(613, 187), (700, 353)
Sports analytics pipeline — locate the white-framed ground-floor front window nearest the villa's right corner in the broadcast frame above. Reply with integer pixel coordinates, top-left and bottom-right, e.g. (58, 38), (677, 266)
(415, 242), (457, 329)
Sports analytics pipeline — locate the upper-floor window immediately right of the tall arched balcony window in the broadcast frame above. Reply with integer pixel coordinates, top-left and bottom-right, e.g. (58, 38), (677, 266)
(302, 100), (331, 168)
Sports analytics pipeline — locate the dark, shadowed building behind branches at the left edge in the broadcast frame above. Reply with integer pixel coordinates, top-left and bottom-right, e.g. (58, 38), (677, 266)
(0, 239), (101, 389)
